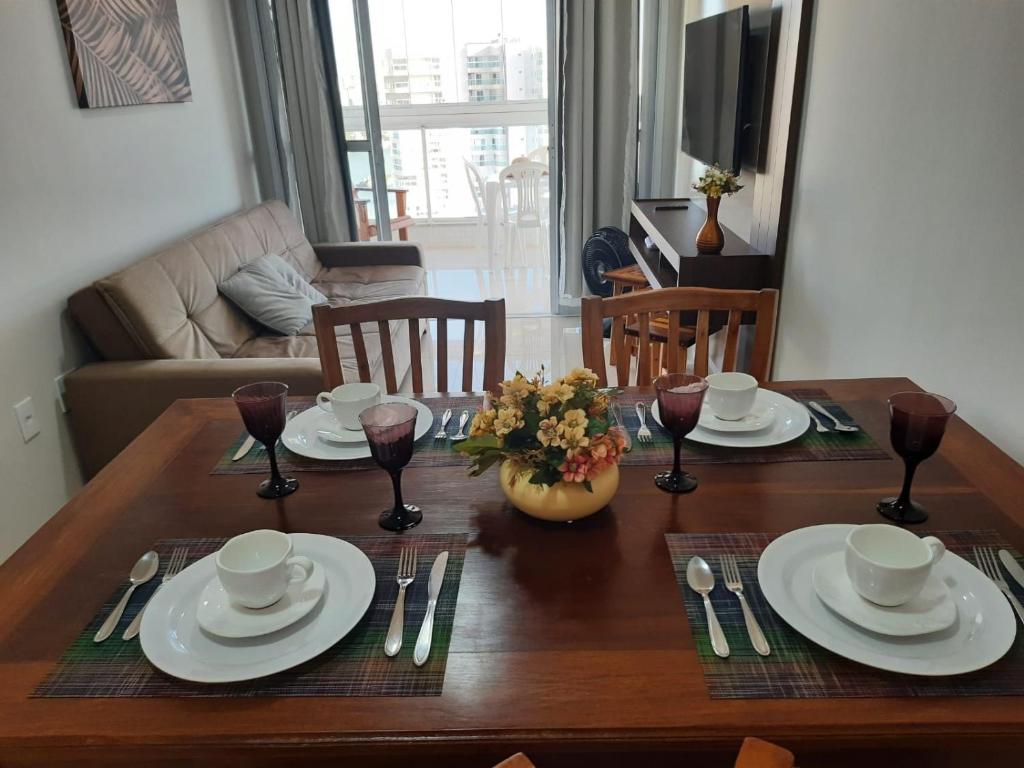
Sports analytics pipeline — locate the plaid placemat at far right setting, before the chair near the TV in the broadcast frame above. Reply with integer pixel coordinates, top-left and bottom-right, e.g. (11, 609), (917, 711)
(615, 389), (890, 468)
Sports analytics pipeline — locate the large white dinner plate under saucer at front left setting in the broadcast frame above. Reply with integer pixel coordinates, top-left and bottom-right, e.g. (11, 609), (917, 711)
(139, 534), (376, 683)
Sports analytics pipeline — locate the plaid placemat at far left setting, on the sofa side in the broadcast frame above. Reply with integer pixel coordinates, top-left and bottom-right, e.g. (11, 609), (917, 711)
(210, 396), (481, 475)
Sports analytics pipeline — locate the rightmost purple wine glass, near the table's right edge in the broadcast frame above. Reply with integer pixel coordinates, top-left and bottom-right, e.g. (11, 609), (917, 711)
(878, 392), (956, 524)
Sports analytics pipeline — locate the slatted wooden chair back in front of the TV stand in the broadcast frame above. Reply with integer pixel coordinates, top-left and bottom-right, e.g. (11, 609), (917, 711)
(582, 288), (778, 386)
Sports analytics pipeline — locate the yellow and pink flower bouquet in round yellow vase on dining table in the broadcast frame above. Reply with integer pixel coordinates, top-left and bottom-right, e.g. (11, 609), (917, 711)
(456, 368), (626, 521)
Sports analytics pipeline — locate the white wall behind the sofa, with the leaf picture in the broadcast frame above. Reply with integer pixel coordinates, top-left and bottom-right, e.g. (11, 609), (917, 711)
(0, 0), (257, 560)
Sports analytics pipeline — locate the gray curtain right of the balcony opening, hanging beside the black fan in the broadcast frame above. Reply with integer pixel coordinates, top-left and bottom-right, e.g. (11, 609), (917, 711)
(558, 0), (638, 308)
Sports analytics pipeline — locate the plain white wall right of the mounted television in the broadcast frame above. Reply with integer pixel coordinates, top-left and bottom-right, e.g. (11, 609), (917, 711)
(775, 0), (1024, 461)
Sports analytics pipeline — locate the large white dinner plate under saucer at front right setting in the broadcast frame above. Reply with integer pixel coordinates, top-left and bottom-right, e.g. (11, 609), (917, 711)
(758, 525), (1017, 676)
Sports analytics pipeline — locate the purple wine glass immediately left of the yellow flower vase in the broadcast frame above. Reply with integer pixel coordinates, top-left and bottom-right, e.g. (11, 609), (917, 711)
(359, 402), (423, 530)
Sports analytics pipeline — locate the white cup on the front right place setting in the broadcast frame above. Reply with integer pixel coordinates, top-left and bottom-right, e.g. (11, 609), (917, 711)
(846, 524), (946, 607)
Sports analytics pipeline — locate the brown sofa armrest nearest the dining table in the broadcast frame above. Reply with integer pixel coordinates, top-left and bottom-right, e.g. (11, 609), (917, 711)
(65, 357), (323, 478)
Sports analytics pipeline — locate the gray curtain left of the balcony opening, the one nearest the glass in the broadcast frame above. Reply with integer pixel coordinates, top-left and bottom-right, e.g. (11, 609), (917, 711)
(273, 0), (353, 243)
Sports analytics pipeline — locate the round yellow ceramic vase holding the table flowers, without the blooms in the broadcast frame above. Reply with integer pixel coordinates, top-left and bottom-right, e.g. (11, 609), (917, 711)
(501, 462), (618, 522)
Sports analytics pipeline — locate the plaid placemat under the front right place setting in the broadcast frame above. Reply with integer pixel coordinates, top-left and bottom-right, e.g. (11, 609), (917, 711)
(665, 530), (1024, 698)
